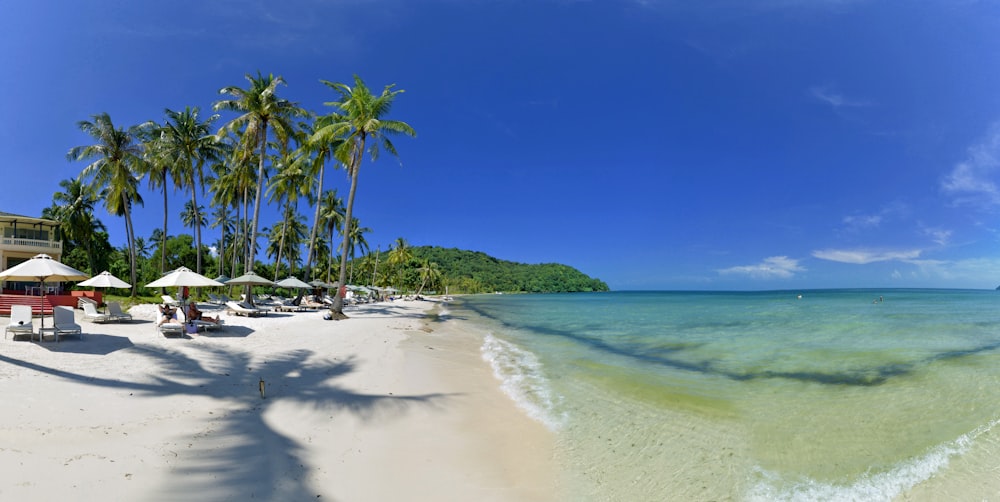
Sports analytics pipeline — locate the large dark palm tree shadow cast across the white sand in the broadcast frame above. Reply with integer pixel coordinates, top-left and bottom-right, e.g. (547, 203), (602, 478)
(0, 346), (452, 500)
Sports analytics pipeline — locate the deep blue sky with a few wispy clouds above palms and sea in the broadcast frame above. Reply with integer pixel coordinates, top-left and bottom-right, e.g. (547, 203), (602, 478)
(0, 0), (1000, 289)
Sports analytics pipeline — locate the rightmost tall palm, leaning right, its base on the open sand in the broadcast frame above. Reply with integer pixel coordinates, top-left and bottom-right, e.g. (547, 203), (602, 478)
(312, 75), (416, 318)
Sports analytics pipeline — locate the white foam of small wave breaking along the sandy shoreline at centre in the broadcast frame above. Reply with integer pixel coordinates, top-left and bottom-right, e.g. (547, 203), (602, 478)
(482, 334), (565, 430)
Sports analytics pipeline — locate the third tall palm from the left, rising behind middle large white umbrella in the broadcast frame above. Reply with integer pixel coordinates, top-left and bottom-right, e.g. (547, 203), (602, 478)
(160, 107), (224, 274)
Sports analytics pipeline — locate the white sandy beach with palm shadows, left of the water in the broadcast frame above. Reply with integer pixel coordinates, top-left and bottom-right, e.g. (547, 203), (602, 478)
(0, 301), (560, 501)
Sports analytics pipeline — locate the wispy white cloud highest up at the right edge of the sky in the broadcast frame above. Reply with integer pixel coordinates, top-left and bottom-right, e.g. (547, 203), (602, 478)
(941, 123), (1000, 209)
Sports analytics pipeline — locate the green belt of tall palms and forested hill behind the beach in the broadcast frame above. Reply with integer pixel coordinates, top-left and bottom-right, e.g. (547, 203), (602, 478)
(43, 72), (607, 306)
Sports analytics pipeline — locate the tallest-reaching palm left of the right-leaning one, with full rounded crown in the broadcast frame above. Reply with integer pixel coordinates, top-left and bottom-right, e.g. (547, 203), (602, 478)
(213, 72), (305, 284)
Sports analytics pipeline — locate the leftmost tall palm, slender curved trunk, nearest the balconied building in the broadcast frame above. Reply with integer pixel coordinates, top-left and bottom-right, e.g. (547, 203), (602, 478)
(66, 113), (145, 297)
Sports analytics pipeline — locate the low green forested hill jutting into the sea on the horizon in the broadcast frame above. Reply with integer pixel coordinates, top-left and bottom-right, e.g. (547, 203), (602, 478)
(404, 246), (609, 293)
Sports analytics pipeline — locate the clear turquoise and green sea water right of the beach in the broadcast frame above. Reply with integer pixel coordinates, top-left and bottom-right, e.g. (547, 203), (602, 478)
(446, 290), (1000, 501)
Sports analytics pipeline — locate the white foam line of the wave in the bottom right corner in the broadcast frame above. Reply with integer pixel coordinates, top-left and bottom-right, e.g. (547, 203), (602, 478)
(747, 418), (1000, 502)
